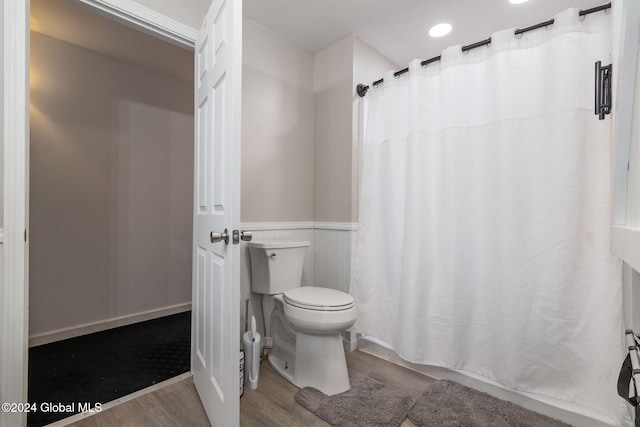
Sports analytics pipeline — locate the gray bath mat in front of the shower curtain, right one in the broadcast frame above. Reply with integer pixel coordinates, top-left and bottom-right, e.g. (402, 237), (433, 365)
(409, 380), (569, 427)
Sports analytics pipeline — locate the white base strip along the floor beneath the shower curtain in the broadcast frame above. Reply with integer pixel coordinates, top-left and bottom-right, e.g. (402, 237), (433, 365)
(358, 336), (616, 427)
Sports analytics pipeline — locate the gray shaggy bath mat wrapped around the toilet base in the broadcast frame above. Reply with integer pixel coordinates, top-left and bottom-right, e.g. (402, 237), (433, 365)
(295, 371), (416, 427)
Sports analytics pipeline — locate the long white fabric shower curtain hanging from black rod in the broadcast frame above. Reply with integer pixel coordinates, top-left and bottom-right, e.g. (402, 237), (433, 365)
(351, 9), (629, 424)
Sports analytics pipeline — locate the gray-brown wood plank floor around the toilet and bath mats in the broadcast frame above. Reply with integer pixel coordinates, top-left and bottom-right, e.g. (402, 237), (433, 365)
(65, 351), (435, 427)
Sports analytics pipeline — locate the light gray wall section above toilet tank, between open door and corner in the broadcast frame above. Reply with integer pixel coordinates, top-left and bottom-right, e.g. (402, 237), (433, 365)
(241, 21), (314, 222)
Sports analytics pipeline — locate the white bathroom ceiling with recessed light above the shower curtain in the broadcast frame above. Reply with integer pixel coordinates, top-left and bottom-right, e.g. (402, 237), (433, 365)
(244, 0), (606, 67)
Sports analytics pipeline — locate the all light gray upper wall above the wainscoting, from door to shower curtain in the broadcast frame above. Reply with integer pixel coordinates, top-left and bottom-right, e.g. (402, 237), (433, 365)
(241, 28), (396, 226)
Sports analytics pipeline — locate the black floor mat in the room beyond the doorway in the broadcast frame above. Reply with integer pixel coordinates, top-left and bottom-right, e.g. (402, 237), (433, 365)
(27, 312), (191, 427)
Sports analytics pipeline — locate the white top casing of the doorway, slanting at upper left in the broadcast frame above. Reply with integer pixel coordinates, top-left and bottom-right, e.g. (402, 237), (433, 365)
(71, 0), (198, 51)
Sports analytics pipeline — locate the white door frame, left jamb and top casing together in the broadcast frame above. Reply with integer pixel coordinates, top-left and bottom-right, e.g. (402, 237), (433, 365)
(0, 0), (198, 427)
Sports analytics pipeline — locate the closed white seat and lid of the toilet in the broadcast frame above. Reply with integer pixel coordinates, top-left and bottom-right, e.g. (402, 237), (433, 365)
(283, 286), (353, 311)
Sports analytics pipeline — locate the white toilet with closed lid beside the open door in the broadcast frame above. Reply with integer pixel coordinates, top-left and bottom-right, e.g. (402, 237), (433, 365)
(247, 241), (356, 395)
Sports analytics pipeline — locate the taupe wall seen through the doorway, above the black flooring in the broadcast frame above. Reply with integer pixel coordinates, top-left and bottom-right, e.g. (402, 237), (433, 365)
(29, 33), (193, 335)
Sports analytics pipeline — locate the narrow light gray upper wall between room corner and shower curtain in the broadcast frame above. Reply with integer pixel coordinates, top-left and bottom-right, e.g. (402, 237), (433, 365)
(314, 35), (397, 222)
